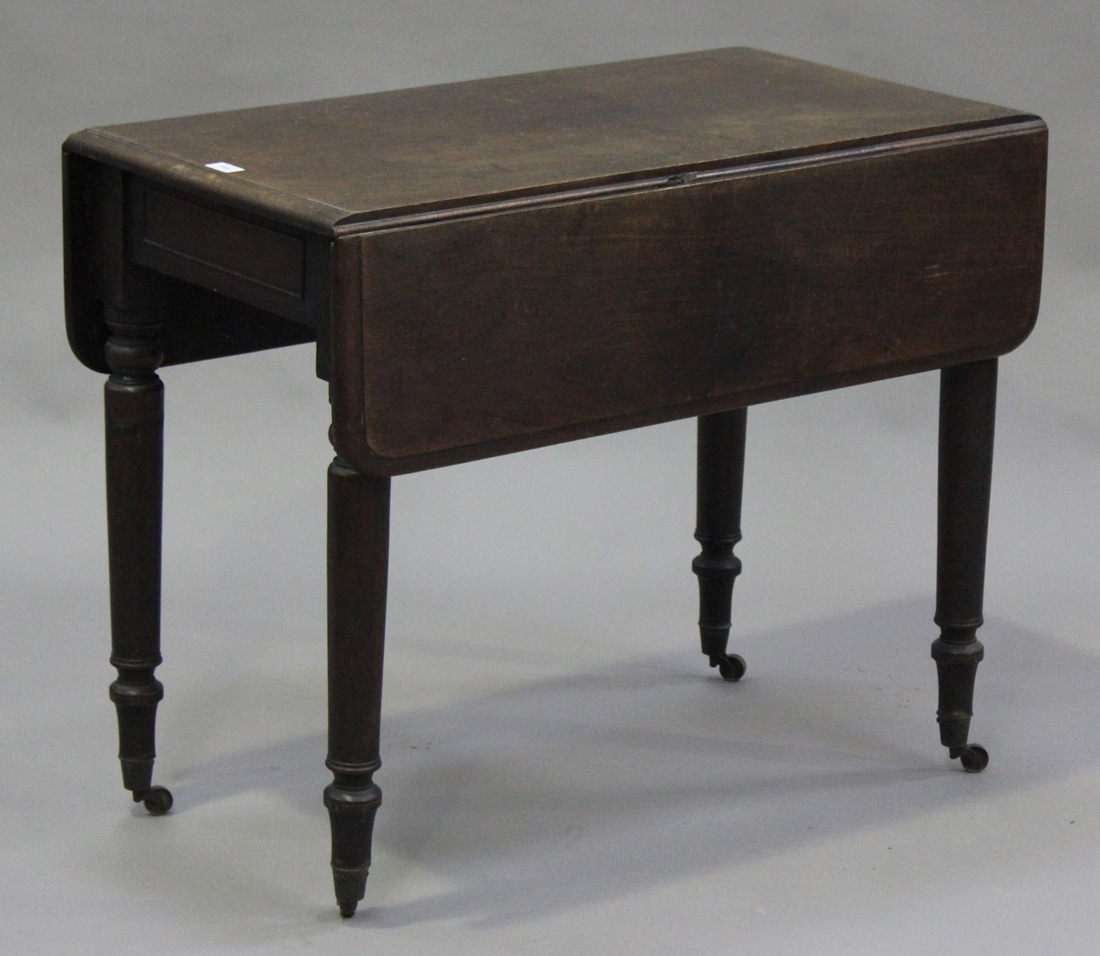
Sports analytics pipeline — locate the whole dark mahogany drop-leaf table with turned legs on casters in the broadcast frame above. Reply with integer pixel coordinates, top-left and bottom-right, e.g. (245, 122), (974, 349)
(63, 48), (1046, 915)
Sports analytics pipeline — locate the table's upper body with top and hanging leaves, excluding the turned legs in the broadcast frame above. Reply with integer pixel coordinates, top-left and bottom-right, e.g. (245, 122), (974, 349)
(66, 50), (1046, 475)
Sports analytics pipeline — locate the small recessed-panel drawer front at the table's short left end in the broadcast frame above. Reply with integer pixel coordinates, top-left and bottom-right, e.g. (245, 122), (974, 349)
(128, 182), (306, 319)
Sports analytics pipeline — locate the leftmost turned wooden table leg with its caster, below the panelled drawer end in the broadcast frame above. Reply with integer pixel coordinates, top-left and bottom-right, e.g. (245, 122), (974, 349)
(103, 308), (172, 814)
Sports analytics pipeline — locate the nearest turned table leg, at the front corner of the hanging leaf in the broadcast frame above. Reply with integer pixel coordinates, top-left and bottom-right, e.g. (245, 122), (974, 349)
(325, 458), (389, 916)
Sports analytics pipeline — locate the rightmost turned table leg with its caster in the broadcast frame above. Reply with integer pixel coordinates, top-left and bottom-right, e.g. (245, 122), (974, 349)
(932, 359), (997, 773)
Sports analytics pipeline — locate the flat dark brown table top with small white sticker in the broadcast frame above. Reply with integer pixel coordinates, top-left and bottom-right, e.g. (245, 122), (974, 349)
(66, 47), (1034, 235)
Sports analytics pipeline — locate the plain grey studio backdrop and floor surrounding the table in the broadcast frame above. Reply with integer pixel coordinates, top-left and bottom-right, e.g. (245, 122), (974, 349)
(0, 0), (1100, 954)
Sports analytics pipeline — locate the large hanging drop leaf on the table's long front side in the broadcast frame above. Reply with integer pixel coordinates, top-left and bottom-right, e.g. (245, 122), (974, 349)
(337, 130), (1045, 469)
